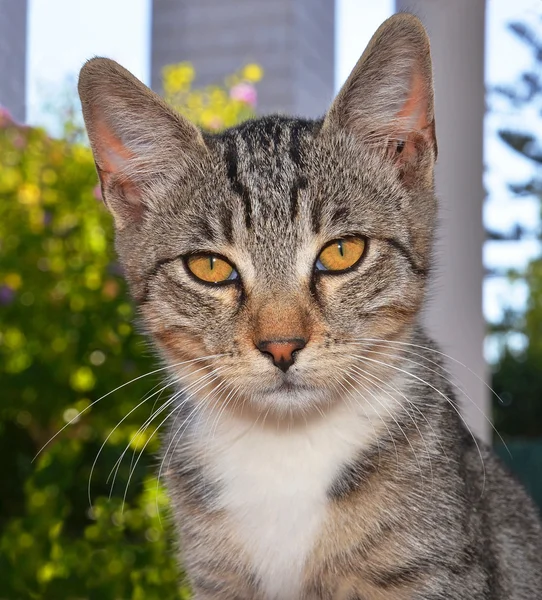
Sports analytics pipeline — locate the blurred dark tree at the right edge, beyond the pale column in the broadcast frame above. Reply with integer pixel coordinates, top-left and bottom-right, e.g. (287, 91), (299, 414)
(490, 20), (542, 506)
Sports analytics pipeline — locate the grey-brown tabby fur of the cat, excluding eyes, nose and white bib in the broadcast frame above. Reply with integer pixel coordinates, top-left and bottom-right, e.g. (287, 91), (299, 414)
(80, 15), (542, 600)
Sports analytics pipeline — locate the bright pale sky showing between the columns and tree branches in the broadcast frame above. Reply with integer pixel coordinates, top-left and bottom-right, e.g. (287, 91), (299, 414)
(27, 0), (542, 340)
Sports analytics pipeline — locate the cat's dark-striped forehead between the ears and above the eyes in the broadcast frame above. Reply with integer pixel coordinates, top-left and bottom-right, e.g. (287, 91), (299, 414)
(165, 116), (406, 272)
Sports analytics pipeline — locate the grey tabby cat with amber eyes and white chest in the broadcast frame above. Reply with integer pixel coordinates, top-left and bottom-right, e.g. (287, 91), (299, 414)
(79, 14), (542, 600)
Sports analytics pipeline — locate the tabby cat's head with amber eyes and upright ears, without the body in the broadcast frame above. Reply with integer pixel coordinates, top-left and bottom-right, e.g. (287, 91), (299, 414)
(79, 15), (436, 413)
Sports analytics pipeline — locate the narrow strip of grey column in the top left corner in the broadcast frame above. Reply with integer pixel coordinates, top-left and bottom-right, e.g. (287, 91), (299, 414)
(0, 0), (27, 122)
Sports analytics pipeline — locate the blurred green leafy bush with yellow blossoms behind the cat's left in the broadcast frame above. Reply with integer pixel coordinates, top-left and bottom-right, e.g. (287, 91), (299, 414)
(0, 66), (260, 600)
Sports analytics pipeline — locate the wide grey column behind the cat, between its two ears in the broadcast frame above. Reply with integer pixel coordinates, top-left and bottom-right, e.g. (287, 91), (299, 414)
(151, 0), (335, 117)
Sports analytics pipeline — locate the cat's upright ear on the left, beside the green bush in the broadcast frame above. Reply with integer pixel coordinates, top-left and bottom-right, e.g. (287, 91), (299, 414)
(79, 58), (205, 228)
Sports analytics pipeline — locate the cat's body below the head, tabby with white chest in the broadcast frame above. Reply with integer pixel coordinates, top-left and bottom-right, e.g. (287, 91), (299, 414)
(165, 332), (542, 600)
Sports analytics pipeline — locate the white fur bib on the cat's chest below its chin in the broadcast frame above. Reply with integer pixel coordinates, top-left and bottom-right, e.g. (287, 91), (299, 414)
(193, 386), (398, 600)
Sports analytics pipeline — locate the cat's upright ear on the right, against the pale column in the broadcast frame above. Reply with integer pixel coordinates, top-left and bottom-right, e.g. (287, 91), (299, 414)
(324, 13), (437, 178)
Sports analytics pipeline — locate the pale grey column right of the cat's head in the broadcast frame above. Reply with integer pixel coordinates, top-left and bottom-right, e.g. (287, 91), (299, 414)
(396, 0), (491, 441)
